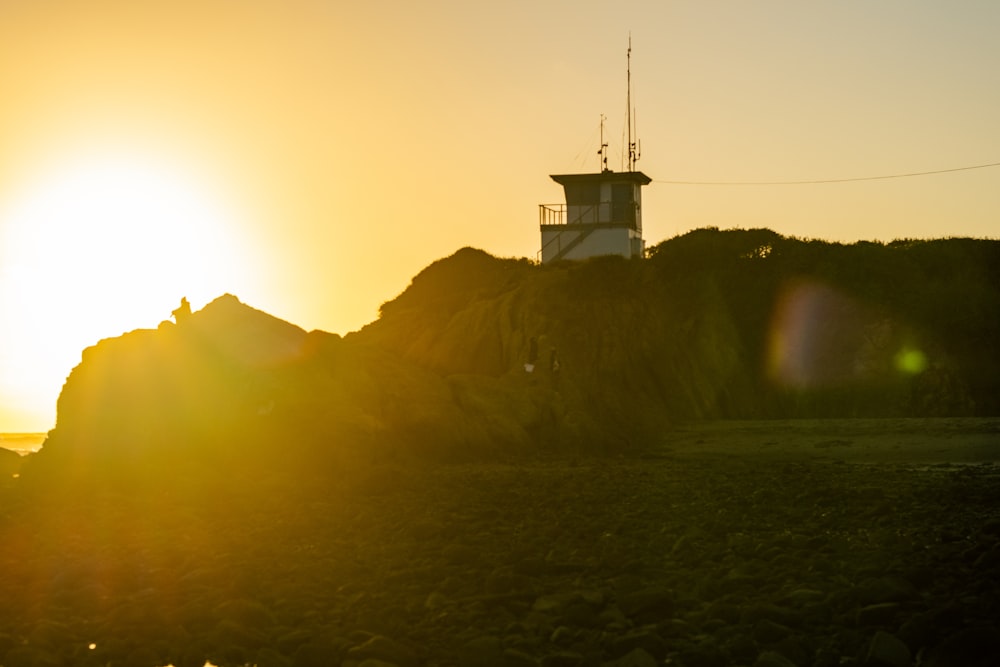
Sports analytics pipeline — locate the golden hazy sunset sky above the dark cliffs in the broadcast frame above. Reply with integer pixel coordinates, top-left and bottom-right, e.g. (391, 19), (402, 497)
(0, 0), (1000, 432)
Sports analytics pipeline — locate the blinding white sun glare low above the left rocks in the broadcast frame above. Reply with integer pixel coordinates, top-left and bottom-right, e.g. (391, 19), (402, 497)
(0, 150), (256, 434)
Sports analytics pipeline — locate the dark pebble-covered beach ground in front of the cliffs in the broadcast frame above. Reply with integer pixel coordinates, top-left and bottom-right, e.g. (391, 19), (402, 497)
(0, 420), (1000, 667)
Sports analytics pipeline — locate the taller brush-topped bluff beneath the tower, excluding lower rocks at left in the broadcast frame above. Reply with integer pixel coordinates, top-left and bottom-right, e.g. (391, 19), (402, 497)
(358, 229), (1000, 422)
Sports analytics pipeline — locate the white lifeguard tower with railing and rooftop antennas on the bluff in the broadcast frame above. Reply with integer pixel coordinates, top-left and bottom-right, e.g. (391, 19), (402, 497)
(538, 37), (652, 264)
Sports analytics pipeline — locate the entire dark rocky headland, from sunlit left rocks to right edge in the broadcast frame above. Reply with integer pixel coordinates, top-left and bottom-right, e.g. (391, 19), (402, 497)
(26, 229), (1000, 488)
